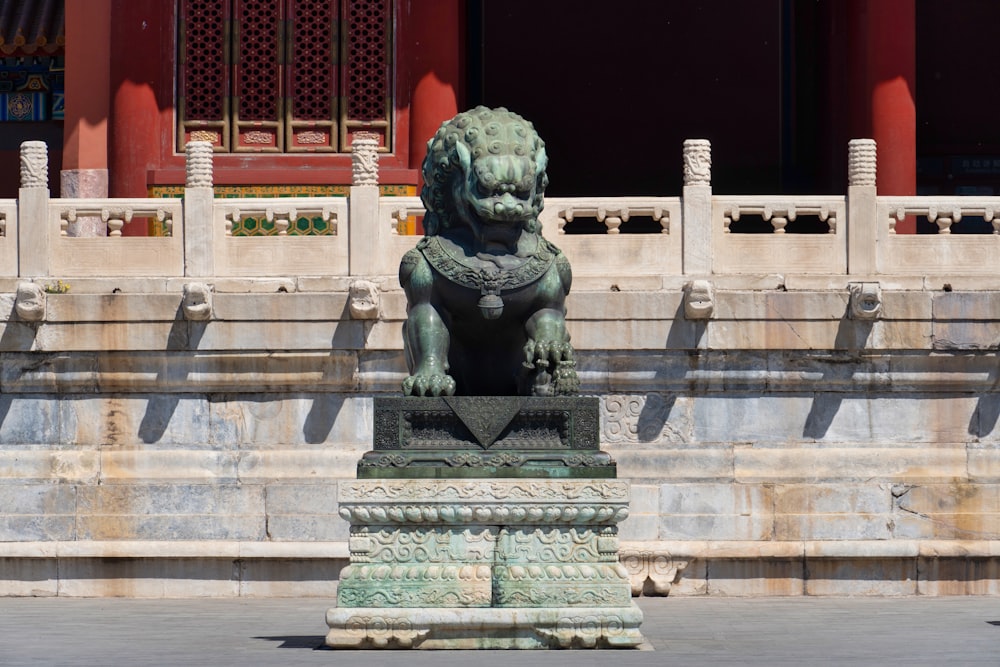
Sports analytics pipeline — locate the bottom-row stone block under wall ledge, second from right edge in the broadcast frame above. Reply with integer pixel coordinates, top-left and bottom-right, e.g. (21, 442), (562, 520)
(805, 558), (917, 596)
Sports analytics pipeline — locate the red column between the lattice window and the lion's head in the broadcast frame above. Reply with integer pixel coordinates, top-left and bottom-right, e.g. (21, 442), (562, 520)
(400, 0), (465, 179)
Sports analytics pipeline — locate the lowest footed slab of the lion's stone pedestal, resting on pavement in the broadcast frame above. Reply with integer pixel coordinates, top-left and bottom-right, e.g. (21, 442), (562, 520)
(326, 603), (644, 650)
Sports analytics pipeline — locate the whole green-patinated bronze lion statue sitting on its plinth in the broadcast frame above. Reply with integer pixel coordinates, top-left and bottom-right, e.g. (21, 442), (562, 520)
(399, 107), (579, 396)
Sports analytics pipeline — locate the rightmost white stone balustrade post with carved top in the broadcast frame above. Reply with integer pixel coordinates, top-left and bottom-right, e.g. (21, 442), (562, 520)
(847, 139), (879, 276)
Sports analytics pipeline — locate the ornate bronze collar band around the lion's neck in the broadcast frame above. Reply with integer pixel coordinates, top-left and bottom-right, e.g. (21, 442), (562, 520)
(417, 236), (559, 294)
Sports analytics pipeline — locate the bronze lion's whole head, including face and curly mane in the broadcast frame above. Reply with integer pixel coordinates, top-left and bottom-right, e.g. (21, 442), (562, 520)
(420, 106), (549, 236)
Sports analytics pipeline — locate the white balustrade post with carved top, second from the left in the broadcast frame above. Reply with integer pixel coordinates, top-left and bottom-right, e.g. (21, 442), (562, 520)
(183, 141), (215, 278)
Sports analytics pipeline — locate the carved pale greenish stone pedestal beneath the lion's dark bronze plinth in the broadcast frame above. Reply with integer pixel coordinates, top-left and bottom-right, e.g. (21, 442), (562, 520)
(326, 479), (643, 649)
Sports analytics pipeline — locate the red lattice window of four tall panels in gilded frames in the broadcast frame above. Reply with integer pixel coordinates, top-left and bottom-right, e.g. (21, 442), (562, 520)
(177, 0), (392, 152)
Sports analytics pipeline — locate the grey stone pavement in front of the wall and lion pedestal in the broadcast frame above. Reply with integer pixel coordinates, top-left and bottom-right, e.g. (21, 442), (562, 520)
(0, 597), (1000, 667)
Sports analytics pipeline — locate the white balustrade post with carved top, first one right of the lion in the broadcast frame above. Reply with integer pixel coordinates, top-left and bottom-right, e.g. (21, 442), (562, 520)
(681, 139), (712, 275)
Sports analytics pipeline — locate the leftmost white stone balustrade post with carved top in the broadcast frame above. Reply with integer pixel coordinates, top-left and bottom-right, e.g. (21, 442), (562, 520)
(17, 141), (53, 278)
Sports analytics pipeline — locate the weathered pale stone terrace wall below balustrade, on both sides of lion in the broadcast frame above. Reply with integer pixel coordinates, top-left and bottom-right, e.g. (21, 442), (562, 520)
(0, 284), (1000, 597)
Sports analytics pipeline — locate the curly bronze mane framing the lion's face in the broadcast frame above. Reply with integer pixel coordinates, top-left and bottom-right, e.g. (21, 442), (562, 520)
(420, 106), (549, 236)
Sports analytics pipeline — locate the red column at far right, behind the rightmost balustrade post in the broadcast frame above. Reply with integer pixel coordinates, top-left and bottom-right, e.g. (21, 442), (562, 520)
(848, 0), (917, 234)
